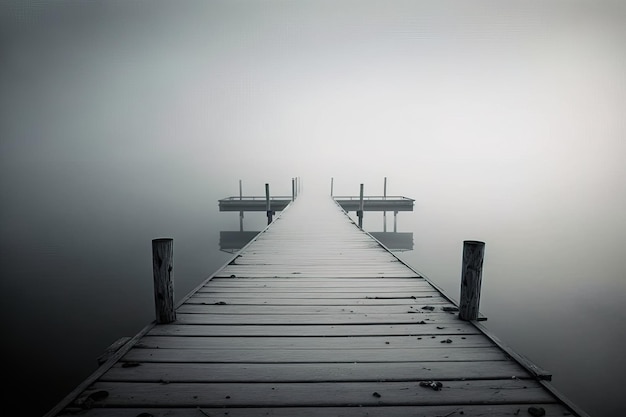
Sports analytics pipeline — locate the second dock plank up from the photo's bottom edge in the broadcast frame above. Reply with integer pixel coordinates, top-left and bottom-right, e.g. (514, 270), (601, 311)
(77, 379), (554, 407)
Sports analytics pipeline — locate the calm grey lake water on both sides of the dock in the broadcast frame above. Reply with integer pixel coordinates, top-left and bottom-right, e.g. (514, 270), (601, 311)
(1, 185), (626, 416)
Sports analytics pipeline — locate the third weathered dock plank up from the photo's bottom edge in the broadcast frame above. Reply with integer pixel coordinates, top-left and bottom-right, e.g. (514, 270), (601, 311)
(101, 361), (527, 382)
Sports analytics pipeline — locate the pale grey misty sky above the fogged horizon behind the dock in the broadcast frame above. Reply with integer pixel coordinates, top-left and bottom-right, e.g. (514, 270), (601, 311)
(0, 0), (626, 262)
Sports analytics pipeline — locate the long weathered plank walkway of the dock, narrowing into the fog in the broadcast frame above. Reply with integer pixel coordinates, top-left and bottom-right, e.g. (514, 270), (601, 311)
(46, 187), (585, 417)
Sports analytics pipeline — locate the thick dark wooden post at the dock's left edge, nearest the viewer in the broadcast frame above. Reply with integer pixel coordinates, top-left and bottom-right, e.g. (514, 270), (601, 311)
(152, 238), (176, 324)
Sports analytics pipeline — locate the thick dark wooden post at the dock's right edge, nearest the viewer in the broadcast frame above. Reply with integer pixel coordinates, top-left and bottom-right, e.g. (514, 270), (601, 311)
(459, 240), (485, 321)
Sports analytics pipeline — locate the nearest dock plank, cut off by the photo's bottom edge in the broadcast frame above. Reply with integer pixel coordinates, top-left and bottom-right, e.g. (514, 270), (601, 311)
(56, 403), (570, 417)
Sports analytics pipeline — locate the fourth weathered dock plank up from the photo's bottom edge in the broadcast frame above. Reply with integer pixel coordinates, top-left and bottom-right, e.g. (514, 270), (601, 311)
(122, 344), (508, 363)
